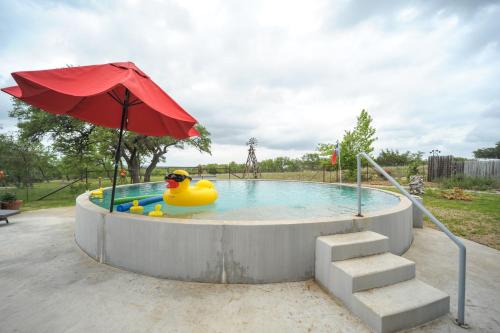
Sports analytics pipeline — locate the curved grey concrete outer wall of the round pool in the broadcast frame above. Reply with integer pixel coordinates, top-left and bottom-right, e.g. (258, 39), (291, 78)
(75, 182), (413, 283)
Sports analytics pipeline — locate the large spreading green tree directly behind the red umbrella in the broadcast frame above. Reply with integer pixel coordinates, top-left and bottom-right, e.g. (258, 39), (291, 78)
(9, 100), (212, 183)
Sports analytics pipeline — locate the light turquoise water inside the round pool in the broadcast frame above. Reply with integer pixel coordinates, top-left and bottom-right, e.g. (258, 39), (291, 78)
(91, 180), (399, 220)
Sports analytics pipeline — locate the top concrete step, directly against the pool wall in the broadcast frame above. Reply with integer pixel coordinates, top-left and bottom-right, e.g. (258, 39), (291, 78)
(315, 231), (389, 290)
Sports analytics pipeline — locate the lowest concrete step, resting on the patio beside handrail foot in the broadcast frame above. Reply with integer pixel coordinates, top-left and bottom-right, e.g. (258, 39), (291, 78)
(350, 279), (450, 333)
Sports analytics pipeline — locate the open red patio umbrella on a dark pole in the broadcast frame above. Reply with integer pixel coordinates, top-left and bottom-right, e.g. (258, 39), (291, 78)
(2, 62), (199, 212)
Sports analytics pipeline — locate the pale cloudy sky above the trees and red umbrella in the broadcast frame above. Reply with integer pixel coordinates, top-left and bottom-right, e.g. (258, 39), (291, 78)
(0, 0), (500, 165)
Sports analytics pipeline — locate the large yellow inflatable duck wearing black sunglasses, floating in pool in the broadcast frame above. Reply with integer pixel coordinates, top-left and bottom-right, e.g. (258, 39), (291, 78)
(163, 170), (217, 206)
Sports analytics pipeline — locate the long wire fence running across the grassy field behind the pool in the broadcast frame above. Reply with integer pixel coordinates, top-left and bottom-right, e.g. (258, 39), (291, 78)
(0, 165), (426, 206)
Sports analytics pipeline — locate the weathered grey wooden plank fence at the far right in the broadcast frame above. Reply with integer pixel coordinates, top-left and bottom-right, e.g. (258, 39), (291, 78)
(427, 156), (500, 181)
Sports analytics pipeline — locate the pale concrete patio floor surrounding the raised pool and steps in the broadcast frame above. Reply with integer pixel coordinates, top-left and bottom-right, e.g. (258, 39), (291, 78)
(0, 208), (500, 332)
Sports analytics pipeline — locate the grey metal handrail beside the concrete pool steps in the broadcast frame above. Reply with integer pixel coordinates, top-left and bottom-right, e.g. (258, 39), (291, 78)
(356, 152), (467, 327)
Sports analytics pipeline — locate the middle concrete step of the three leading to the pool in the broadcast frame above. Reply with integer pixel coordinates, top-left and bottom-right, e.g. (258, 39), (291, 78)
(330, 252), (415, 305)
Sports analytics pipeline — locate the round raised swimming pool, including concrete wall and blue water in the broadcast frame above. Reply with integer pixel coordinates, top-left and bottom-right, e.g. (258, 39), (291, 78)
(75, 180), (413, 283)
